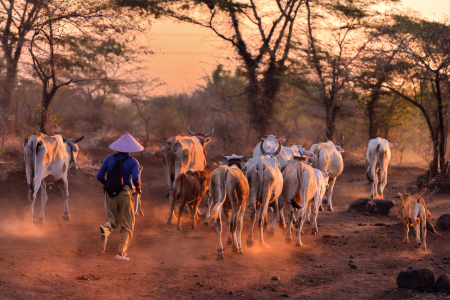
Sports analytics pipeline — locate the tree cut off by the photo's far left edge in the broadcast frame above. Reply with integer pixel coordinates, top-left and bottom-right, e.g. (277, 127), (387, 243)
(0, 0), (42, 122)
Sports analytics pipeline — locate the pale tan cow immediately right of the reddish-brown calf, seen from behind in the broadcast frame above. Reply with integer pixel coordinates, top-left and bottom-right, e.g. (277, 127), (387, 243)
(205, 159), (250, 260)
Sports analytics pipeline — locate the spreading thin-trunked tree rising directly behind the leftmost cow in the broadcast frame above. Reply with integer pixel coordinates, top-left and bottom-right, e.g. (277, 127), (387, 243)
(28, 0), (139, 133)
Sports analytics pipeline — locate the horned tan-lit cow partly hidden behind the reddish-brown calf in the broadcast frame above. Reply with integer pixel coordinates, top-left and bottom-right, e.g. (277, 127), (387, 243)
(161, 127), (214, 224)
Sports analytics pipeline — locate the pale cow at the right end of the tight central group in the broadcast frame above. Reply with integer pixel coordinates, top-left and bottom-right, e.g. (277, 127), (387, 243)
(309, 137), (344, 211)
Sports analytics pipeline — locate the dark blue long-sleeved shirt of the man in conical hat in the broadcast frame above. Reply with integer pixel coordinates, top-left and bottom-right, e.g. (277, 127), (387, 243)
(97, 152), (141, 189)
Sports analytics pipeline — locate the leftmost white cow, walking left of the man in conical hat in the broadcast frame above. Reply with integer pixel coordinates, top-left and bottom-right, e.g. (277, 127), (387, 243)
(24, 133), (84, 223)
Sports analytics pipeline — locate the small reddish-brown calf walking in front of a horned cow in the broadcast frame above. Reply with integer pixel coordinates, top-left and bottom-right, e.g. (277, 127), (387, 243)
(171, 170), (212, 230)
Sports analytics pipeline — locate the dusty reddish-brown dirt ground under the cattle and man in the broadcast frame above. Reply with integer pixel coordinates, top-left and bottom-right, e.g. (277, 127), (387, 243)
(0, 150), (450, 299)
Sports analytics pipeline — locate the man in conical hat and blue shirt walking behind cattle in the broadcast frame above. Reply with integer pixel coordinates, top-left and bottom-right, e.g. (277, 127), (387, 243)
(97, 133), (144, 261)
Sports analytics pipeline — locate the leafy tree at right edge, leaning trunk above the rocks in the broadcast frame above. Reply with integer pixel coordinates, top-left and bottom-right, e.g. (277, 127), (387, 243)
(380, 15), (450, 177)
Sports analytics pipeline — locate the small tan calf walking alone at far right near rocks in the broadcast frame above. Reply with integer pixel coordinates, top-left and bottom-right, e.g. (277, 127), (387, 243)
(398, 193), (431, 250)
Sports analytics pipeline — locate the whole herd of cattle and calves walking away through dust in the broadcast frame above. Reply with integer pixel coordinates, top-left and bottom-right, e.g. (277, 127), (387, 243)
(24, 127), (429, 260)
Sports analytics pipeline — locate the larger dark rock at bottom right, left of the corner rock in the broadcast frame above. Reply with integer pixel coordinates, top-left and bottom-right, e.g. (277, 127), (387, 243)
(397, 267), (434, 293)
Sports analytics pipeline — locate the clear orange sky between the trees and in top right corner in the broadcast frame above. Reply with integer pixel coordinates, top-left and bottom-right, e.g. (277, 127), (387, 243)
(148, 0), (450, 94)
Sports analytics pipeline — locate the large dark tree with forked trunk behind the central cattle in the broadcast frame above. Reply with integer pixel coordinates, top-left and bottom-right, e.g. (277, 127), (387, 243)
(117, 0), (304, 135)
